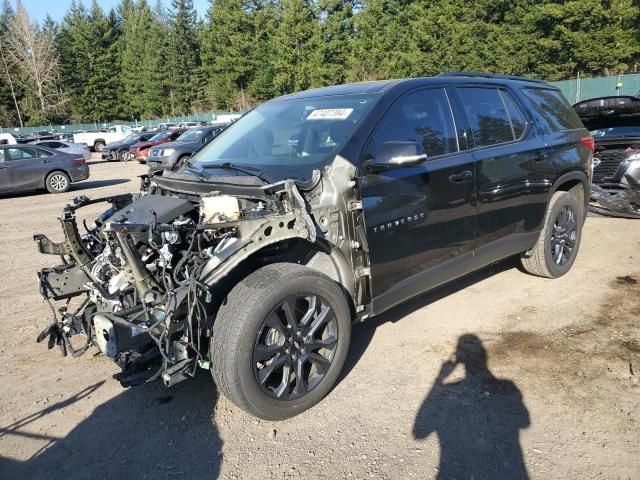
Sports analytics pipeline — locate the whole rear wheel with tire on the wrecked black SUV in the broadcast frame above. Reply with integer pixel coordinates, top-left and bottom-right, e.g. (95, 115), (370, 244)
(521, 192), (584, 278)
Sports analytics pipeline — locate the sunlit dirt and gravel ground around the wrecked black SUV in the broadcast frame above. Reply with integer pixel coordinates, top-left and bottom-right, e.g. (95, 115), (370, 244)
(0, 158), (640, 479)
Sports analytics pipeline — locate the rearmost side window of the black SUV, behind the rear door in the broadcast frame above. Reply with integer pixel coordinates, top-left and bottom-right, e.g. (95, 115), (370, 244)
(523, 88), (584, 133)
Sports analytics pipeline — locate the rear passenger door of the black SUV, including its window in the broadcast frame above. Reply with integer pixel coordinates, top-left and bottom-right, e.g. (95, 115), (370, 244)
(456, 86), (554, 268)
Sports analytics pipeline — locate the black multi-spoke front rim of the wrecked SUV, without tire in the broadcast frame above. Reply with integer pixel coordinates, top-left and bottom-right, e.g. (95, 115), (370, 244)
(253, 294), (338, 400)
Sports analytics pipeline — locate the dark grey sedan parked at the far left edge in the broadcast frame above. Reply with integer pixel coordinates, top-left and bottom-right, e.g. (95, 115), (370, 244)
(0, 145), (89, 193)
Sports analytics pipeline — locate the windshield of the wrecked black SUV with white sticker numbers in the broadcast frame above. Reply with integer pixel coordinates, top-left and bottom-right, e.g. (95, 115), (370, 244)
(191, 95), (379, 181)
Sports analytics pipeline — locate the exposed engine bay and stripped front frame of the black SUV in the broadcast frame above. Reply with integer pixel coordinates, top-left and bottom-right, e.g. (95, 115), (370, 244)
(34, 156), (370, 386)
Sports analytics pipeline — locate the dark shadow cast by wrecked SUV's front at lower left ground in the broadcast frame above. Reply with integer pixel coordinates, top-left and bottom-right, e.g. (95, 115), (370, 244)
(0, 372), (222, 480)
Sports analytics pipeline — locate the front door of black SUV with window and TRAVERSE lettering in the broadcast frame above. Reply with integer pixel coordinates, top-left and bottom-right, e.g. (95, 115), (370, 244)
(360, 88), (476, 313)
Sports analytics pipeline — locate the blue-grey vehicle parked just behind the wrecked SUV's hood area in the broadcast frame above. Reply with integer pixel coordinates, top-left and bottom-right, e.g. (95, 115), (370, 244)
(147, 127), (223, 175)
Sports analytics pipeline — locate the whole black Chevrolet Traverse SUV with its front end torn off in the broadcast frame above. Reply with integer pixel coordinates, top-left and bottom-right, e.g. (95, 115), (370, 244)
(35, 73), (593, 419)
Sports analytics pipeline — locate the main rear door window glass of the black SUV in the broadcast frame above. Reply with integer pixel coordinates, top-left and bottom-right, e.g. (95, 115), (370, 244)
(458, 88), (514, 147)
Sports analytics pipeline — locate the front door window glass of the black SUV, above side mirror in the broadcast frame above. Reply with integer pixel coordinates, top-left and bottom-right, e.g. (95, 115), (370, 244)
(374, 88), (458, 157)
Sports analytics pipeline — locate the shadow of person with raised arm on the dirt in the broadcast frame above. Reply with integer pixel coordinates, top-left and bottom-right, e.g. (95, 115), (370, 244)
(413, 334), (530, 480)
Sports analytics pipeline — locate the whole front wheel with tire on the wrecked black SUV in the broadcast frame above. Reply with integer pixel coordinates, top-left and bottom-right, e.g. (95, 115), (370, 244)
(210, 263), (351, 420)
